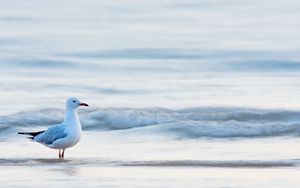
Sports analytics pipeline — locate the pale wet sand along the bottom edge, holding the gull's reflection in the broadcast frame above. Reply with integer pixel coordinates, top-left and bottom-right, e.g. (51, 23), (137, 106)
(0, 159), (300, 187)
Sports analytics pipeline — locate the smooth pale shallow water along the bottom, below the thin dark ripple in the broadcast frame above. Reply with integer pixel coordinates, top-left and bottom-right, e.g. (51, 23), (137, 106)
(0, 166), (299, 187)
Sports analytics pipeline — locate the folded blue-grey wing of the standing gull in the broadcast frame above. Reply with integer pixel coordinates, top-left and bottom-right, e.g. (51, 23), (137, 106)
(34, 124), (67, 144)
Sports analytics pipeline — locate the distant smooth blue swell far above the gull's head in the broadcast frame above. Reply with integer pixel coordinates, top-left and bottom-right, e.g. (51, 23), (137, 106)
(0, 49), (300, 74)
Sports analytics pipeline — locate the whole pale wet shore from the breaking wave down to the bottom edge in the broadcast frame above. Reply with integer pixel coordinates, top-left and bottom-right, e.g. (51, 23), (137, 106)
(0, 132), (300, 188)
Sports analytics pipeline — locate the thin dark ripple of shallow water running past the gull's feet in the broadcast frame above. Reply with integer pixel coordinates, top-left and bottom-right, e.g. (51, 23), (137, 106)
(0, 158), (299, 168)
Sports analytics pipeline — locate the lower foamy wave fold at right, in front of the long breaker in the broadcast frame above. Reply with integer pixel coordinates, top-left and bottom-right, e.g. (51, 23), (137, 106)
(130, 121), (300, 139)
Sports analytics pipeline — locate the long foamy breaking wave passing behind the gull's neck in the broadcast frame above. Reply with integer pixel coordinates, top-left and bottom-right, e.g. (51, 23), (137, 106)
(0, 107), (300, 138)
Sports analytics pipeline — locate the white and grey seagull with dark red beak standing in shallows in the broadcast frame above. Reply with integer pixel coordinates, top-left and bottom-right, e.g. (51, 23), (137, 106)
(18, 97), (89, 159)
